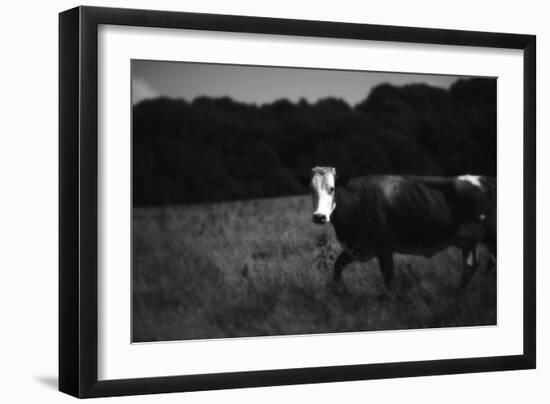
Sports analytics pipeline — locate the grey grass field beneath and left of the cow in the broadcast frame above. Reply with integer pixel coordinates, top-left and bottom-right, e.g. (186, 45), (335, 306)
(132, 197), (496, 342)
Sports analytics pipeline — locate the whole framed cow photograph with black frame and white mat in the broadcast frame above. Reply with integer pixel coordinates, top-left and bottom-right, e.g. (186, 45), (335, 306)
(59, 7), (536, 397)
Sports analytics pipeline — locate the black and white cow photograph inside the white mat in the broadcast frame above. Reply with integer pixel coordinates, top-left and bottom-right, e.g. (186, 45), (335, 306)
(131, 60), (498, 342)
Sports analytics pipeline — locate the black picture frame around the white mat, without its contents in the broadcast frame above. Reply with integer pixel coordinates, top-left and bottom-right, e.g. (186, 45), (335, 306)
(59, 7), (536, 398)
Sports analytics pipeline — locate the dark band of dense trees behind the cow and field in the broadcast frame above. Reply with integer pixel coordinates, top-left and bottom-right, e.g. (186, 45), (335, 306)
(133, 79), (496, 205)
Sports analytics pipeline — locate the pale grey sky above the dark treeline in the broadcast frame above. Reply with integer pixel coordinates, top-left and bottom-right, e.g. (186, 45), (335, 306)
(132, 60), (468, 106)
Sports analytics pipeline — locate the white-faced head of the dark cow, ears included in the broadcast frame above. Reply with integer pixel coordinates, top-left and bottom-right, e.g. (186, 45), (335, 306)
(298, 167), (349, 224)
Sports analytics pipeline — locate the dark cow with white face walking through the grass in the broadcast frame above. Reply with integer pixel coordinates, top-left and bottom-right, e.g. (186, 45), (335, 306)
(300, 167), (496, 290)
